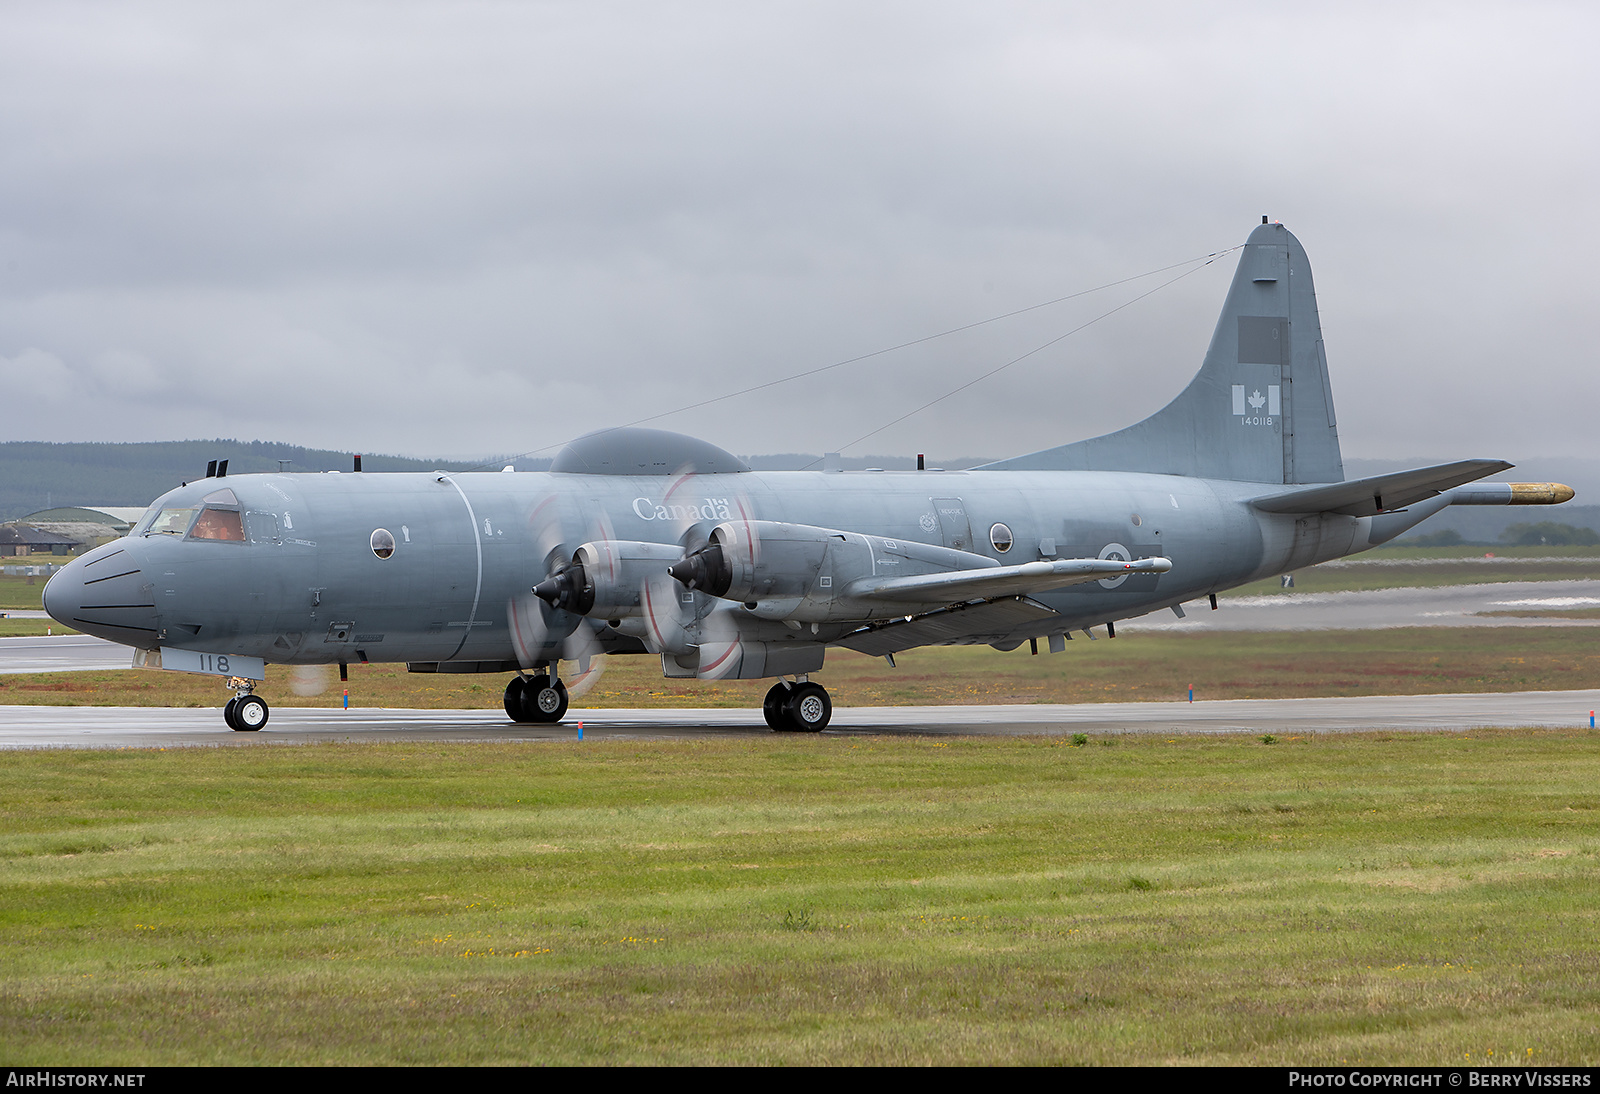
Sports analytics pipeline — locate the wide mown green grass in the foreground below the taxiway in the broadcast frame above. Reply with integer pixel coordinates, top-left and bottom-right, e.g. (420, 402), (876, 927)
(0, 731), (1600, 1065)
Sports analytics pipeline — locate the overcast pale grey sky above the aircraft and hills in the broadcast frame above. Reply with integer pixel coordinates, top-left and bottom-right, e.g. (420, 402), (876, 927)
(0, 0), (1600, 461)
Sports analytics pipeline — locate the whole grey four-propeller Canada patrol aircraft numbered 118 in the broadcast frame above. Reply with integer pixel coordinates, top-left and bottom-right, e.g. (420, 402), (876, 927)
(45, 218), (1573, 731)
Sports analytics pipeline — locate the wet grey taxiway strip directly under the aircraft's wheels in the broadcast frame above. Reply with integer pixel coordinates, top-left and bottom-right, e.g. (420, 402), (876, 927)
(0, 689), (1600, 749)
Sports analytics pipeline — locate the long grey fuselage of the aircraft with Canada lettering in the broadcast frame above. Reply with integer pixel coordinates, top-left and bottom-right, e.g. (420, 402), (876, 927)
(45, 470), (1371, 664)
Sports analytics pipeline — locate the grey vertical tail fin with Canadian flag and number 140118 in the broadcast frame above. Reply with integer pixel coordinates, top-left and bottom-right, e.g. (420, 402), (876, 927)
(984, 218), (1344, 483)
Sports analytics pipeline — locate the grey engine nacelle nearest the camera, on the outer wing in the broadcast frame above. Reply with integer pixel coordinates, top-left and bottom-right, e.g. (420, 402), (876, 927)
(667, 520), (995, 622)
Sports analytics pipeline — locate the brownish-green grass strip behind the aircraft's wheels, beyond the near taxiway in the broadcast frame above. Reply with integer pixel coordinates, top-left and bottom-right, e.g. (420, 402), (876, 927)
(0, 627), (1600, 710)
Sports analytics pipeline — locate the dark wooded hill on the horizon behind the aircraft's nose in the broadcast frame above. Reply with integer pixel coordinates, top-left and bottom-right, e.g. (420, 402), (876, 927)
(0, 440), (492, 520)
